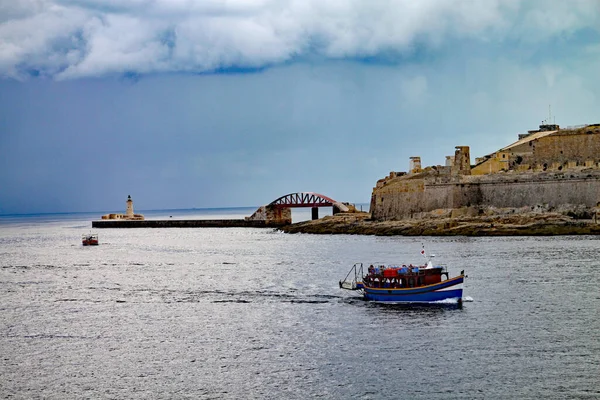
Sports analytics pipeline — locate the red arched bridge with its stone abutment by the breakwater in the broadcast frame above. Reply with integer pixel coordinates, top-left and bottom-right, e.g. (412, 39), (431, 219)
(247, 192), (350, 225)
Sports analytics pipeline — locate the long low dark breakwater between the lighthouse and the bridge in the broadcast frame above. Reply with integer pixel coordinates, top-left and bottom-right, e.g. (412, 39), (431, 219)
(92, 219), (283, 228)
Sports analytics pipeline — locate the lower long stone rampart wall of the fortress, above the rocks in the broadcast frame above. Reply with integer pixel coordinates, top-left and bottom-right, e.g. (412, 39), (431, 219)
(371, 170), (600, 221)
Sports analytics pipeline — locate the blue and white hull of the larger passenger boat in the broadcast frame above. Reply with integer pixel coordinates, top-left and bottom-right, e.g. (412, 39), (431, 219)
(363, 275), (464, 303)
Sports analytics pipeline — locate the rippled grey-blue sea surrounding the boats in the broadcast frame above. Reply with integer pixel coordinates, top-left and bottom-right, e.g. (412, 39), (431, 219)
(0, 208), (600, 399)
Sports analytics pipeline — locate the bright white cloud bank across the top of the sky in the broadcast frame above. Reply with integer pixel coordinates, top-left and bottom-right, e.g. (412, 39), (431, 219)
(0, 0), (600, 79)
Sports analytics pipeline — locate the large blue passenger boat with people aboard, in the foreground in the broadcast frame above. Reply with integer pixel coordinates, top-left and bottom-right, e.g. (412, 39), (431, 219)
(339, 260), (465, 304)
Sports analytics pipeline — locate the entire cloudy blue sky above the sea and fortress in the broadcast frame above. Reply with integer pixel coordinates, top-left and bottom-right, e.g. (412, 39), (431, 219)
(0, 0), (600, 214)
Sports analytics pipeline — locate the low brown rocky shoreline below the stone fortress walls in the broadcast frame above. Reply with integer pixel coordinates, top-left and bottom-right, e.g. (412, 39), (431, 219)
(279, 209), (600, 236)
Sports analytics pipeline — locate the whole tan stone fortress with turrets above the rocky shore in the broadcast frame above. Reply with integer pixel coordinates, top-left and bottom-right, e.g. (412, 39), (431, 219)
(370, 124), (600, 220)
